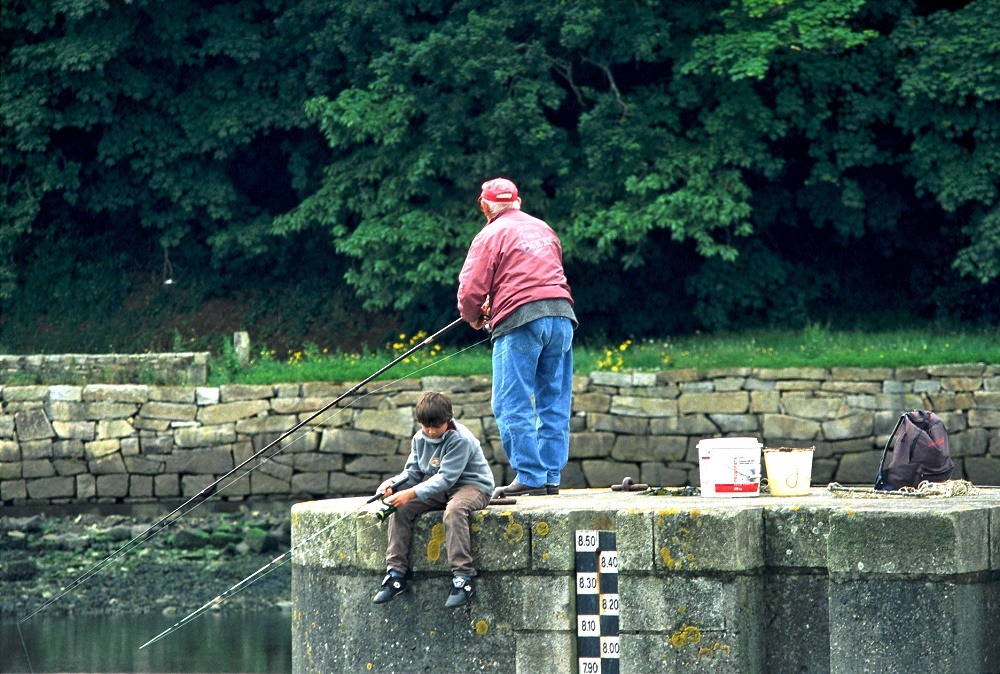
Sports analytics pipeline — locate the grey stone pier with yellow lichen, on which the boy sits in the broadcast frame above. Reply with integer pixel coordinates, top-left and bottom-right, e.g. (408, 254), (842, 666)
(292, 489), (1000, 674)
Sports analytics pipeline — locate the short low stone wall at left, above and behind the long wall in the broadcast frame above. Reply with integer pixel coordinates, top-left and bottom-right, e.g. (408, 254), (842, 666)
(0, 352), (210, 386)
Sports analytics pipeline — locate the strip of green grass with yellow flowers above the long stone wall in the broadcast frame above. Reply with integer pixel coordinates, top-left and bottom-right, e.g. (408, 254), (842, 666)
(209, 325), (1000, 386)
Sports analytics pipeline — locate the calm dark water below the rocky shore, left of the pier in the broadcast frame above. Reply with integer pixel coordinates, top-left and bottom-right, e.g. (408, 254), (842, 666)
(0, 612), (292, 673)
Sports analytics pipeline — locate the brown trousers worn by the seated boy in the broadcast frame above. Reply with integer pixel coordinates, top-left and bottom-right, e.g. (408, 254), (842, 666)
(385, 484), (490, 578)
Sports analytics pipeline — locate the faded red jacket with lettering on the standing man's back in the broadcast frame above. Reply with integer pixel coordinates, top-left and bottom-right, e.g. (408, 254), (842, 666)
(458, 209), (573, 328)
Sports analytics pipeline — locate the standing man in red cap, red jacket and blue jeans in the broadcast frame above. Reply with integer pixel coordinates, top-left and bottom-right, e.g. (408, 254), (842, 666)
(458, 178), (577, 496)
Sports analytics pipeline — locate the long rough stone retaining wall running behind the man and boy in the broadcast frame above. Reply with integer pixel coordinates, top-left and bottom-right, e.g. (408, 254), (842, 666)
(0, 363), (1000, 505)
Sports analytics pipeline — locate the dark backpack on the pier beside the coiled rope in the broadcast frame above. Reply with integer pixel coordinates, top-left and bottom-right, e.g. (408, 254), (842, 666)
(875, 410), (955, 491)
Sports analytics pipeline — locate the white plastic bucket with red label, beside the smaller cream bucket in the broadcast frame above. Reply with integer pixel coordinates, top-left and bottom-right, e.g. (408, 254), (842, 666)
(698, 438), (761, 498)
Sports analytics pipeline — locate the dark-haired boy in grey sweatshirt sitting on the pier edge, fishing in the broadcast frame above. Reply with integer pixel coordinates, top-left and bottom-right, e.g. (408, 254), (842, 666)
(372, 392), (494, 608)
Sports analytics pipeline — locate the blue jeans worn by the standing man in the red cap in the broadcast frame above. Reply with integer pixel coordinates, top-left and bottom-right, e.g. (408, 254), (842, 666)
(493, 316), (573, 487)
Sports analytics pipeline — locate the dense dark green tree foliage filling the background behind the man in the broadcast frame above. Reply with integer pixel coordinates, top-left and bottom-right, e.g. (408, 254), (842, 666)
(0, 0), (1000, 346)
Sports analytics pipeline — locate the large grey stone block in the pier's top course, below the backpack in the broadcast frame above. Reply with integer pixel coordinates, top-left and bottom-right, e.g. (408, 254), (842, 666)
(827, 505), (989, 575)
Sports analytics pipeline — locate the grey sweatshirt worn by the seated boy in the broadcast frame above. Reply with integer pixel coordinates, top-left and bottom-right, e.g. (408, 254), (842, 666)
(392, 419), (494, 501)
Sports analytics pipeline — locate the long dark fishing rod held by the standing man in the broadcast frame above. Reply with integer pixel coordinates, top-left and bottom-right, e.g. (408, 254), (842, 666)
(17, 318), (464, 626)
